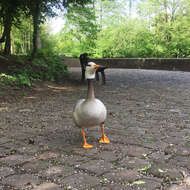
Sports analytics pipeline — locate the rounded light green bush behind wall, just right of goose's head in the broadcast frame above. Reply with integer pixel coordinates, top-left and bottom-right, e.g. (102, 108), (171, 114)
(94, 20), (154, 57)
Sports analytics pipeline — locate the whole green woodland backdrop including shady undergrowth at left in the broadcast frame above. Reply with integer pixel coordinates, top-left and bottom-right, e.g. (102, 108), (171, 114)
(0, 0), (190, 86)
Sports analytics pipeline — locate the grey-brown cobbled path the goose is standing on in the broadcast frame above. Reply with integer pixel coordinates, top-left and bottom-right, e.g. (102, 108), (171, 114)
(0, 68), (190, 190)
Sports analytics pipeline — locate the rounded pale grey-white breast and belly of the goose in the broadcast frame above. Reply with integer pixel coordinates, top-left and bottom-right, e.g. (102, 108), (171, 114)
(73, 99), (107, 127)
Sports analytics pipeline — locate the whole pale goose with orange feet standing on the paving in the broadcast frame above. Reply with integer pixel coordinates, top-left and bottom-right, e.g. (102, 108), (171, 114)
(73, 62), (110, 148)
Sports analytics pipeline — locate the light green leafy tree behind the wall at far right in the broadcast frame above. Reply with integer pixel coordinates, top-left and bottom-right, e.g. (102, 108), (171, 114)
(139, 0), (190, 57)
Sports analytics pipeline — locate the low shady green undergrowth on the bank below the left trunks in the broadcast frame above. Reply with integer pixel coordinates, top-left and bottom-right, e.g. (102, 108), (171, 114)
(0, 55), (68, 87)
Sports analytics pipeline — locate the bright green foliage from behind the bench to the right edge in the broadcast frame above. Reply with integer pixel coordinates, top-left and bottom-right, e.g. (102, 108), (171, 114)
(57, 0), (190, 58)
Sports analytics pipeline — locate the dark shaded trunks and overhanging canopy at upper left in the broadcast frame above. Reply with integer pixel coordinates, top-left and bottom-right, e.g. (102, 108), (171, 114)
(0, 0), (88, 57)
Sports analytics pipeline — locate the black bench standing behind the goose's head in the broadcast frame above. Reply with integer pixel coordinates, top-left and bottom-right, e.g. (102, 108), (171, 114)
(80, 53), (107, 84)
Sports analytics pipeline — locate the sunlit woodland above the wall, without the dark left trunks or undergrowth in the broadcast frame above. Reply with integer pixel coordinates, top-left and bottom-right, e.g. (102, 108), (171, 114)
(0, 0), (190, 58)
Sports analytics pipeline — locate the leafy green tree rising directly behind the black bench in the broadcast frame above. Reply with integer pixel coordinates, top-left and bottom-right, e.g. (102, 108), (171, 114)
(57, 1), (98, 57)
